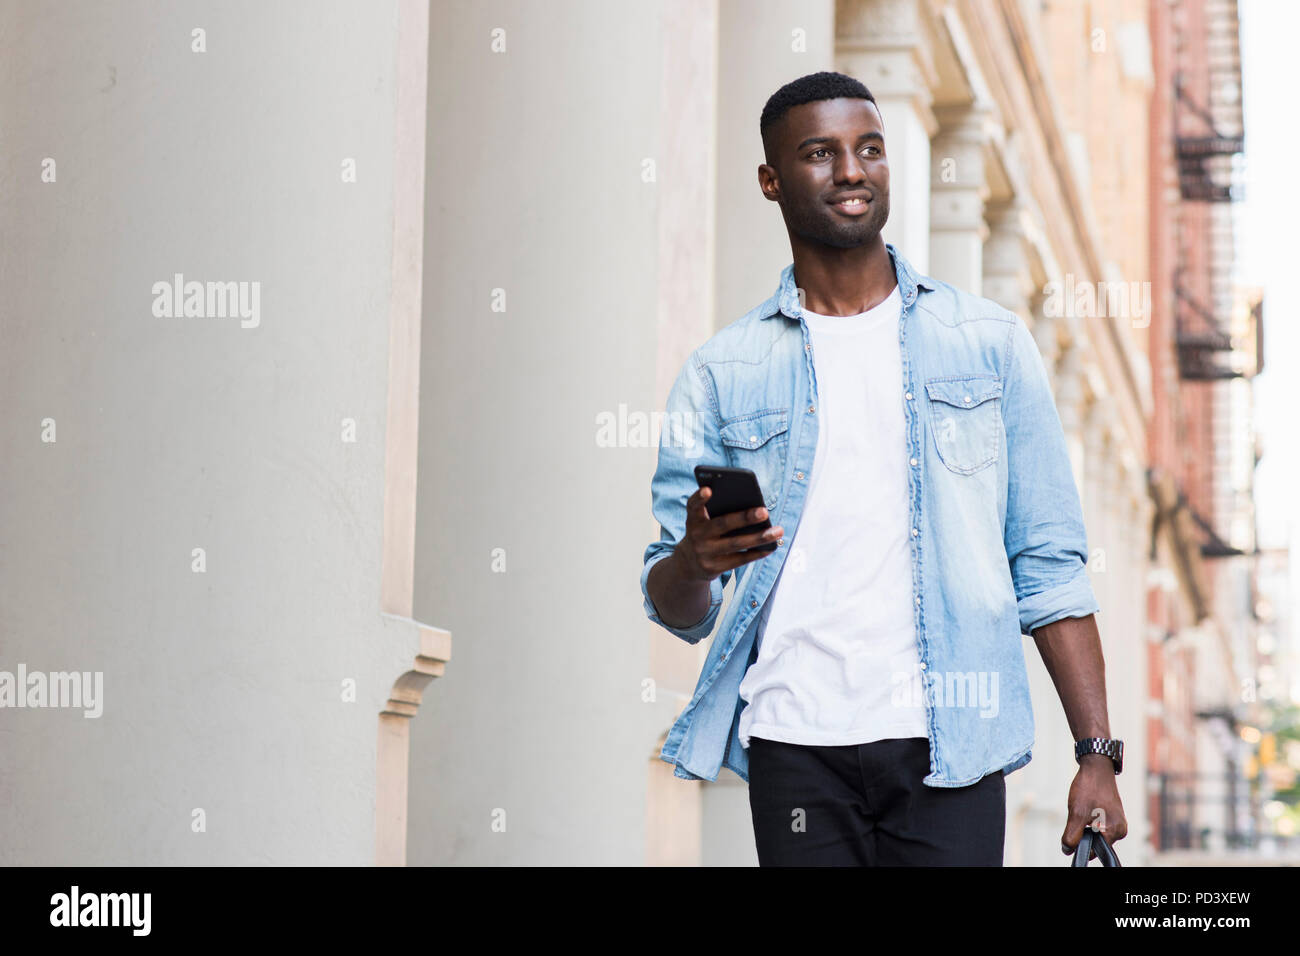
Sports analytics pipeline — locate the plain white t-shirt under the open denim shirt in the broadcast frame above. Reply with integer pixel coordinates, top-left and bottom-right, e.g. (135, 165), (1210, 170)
(740, 286), (927, 747)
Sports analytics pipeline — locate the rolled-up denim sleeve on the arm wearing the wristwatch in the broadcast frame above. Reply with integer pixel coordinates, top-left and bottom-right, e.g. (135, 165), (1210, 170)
(1002, 312), (1101, 635)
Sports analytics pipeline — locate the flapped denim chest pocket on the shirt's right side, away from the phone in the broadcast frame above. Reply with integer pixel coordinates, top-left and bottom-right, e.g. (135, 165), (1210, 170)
(926, 376), (1002, 475)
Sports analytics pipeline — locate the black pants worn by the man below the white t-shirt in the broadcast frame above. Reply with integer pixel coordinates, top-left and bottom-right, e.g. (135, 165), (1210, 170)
(749, 737), (1006, 866)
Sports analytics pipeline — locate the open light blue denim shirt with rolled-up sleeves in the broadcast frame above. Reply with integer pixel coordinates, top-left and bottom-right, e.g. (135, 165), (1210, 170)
(641, 245), (1100, 787)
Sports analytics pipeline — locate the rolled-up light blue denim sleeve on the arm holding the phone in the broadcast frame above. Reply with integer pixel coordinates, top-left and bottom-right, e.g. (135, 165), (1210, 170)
(641, 354), (732, 644)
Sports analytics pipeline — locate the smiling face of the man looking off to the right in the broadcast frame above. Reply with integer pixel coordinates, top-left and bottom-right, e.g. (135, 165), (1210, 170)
(759, 98), (889, 248)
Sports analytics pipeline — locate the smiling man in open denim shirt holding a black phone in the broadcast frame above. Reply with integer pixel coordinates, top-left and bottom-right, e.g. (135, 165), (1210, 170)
(641, 73), (1127, 866)
